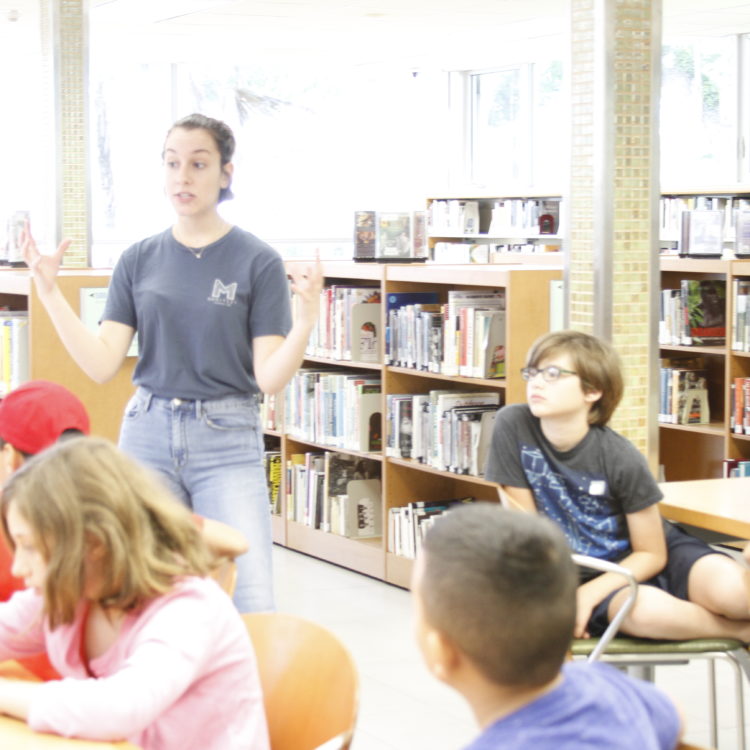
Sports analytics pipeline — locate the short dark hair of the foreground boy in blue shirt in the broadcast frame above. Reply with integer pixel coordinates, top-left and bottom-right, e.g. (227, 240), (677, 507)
(419, 503), (578, 688)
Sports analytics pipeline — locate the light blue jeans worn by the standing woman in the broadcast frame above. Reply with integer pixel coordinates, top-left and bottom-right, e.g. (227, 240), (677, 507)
(120, 387), (274, 612)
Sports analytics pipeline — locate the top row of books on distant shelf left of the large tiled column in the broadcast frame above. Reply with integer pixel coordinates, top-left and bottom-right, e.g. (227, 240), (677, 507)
(427, 198), (560, 237)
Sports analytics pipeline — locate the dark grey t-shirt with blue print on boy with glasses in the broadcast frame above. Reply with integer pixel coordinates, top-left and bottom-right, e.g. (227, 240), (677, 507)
(485, 404), (662, 561)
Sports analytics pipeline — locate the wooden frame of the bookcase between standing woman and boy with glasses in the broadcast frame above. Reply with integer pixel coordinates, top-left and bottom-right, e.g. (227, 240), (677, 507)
(270, 261), (562, 587)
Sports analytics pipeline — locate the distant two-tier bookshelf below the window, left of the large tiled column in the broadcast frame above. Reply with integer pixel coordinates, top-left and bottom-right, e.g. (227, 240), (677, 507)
(426, 193), (562, 266)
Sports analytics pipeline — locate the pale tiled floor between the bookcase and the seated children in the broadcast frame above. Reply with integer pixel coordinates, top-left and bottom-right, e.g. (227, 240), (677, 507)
(274, 547), (750, 750)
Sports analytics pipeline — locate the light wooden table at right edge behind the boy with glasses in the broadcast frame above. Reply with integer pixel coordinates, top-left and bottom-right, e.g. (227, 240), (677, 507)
(659, 477), (750, 539)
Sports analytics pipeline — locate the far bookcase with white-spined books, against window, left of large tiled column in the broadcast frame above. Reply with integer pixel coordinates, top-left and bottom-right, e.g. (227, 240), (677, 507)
(426, 192), (562, 267)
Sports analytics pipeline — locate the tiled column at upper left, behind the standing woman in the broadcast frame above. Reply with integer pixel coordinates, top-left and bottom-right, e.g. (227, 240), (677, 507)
(40, 0), (91, 266)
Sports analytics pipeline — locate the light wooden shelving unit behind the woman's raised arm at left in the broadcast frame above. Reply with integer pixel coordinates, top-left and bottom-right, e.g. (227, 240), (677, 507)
(0, 269), (135, 441)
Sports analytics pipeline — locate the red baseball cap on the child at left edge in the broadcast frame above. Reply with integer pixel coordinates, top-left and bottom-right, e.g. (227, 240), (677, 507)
(0, 380), (90, 455)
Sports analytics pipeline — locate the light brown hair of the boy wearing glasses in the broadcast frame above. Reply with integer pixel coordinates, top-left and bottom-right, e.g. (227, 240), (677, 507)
(526, 331), (625, 427)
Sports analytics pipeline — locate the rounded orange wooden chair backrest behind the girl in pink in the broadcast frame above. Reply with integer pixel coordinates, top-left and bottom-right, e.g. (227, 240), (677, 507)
(242, 612), (359, 750)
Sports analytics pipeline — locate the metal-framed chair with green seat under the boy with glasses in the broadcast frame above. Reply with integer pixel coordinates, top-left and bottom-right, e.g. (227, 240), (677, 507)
(571, 555), (750, 750)
